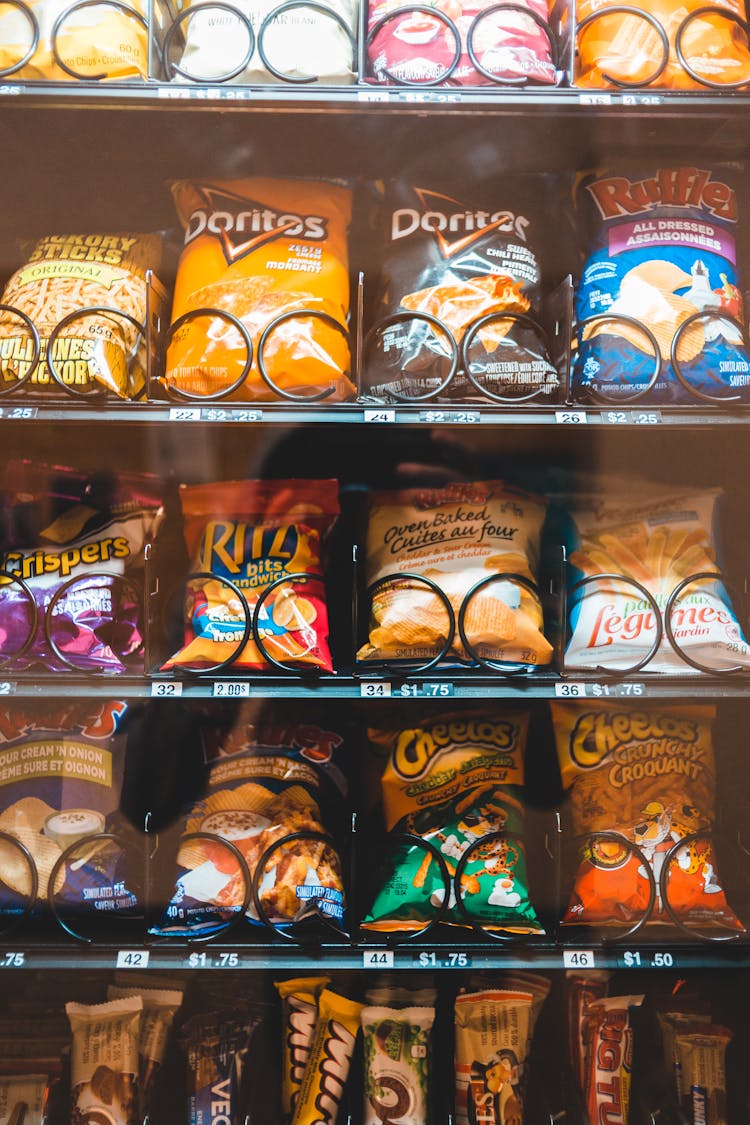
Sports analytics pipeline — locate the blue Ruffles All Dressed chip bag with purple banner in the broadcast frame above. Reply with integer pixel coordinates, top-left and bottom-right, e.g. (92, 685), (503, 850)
(572, 166), (750, 403)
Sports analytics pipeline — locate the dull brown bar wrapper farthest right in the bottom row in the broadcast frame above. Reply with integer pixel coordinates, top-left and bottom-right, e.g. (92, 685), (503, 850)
(675, 1024), (732, 1125)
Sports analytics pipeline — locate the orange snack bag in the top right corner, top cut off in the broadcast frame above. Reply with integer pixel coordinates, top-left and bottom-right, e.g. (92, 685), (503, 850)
(576, 0), (750, 90)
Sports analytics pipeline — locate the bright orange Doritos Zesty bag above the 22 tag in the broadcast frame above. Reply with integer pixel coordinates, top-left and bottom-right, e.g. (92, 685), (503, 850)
(164, 179), (355, 402)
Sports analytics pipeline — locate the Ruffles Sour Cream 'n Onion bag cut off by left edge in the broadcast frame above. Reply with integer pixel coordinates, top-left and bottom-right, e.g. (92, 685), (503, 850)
(0, 701), (137, 917)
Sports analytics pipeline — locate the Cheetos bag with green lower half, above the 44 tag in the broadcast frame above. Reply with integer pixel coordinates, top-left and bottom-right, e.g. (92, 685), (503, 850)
(364, 711), (542, 934)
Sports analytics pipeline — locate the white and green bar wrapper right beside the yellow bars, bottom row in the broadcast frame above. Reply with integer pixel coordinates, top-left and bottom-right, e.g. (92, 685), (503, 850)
(362, 1007), (435, 1125)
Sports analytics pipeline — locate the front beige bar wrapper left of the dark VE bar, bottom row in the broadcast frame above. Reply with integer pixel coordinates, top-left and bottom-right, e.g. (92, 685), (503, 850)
(65, 996), (143, 1125)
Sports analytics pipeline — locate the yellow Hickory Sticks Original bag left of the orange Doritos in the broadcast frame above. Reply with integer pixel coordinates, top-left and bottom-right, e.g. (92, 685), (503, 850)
(0, 232), (164, 398)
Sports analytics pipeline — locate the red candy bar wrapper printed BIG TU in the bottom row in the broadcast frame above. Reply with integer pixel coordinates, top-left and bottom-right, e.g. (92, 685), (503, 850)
(584, 996), (643, 1125)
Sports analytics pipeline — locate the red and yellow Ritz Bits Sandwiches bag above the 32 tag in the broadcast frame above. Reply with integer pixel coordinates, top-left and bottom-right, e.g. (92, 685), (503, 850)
(164, 480), (338, 672)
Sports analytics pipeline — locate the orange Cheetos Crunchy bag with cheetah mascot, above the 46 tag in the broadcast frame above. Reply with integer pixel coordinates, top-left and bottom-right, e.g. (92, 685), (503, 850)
(550, 702), (743, 930)
